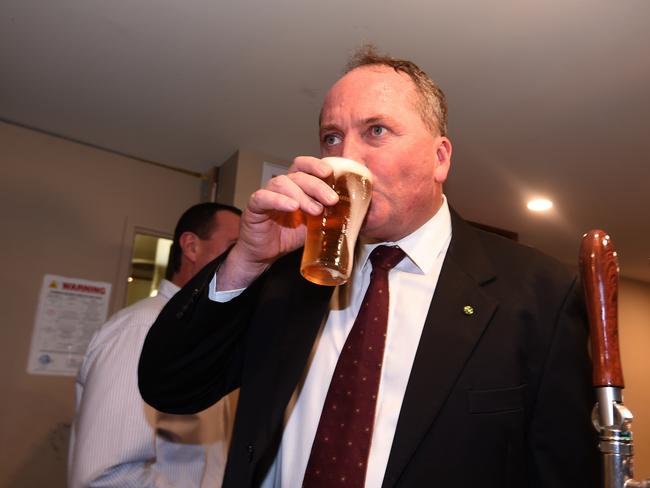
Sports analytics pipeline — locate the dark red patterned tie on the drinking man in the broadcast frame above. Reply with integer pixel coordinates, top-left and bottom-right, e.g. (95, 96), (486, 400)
(302, 246), (405, 488)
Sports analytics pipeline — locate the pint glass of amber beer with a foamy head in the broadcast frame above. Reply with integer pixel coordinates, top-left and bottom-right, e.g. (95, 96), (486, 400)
(300, 157), (372, 286)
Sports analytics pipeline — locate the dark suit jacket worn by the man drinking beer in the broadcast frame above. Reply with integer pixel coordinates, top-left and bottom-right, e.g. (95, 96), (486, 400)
(139, 214), (600, 488)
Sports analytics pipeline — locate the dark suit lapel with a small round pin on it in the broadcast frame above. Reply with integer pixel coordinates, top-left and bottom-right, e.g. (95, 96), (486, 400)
(383, 212), (498, 487)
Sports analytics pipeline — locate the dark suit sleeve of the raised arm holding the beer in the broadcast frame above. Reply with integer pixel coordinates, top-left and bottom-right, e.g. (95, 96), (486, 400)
(138, 256), (262, 414)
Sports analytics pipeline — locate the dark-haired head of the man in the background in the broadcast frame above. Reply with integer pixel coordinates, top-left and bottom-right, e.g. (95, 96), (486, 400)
(165, 202), (241, 286)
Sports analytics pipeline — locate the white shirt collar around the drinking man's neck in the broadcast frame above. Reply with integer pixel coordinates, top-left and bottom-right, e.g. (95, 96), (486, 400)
(356, 195), (451, 274)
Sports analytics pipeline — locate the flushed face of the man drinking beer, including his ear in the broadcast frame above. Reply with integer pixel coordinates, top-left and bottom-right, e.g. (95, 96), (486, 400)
(320, 66), (451, 241)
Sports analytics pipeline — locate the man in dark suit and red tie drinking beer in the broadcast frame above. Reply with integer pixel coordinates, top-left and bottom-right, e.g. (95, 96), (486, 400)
(140, 45), (599, 488)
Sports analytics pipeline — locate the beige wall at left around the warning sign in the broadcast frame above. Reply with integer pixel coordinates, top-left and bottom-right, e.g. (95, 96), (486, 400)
(0, 122), (201, 488)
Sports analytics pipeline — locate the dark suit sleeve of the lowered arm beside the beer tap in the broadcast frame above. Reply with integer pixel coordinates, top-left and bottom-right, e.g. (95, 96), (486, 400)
(528, 281), (601, 488)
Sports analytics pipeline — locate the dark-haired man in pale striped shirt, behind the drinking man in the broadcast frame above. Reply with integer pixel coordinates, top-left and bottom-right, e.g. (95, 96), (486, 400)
(68, 203), (241, 488)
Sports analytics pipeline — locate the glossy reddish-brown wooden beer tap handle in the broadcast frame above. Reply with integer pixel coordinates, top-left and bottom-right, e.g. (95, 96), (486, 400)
(580, 230), (625, 388)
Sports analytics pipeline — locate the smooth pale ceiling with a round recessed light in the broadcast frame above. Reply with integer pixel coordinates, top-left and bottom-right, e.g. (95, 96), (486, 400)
(0, 0), (650, 282)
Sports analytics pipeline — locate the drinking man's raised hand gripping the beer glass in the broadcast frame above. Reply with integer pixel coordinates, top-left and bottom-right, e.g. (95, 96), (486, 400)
(217, 156), (338, 291)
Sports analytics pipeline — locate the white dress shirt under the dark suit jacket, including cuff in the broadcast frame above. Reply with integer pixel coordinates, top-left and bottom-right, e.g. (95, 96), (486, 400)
(210, 198), (451, 488)
